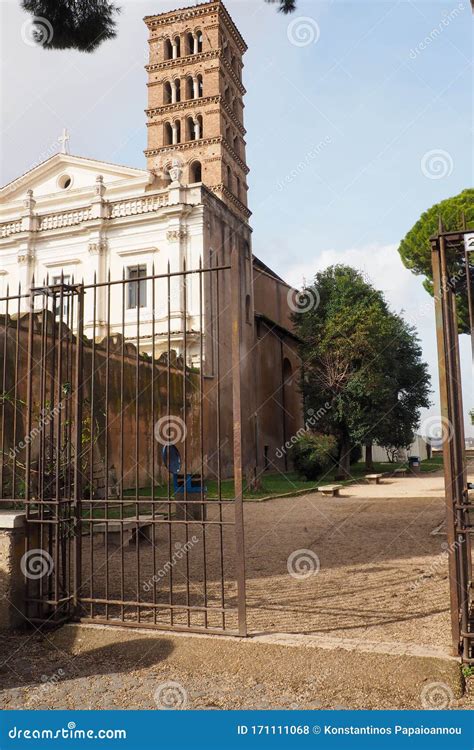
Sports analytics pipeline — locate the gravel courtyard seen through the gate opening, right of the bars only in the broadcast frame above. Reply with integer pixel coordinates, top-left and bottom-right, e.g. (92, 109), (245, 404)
(246, 475), (450, 648)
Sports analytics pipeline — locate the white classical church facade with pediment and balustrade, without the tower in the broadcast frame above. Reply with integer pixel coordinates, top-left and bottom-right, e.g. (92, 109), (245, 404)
(0, 153), (212, 364)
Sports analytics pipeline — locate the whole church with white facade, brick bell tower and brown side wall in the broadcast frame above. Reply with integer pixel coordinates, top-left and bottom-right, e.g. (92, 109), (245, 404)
(0, 0), (302, 470)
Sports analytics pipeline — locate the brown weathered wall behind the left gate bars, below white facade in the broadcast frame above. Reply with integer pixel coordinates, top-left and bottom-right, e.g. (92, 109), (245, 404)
(0, 312), (200, 498)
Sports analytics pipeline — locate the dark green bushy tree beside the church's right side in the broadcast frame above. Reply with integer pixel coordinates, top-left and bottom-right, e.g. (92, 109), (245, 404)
(294, 265), (430, 476)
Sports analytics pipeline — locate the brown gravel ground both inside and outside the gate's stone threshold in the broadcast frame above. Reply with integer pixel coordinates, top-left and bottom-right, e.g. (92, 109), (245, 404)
(0, 474), (470, 708)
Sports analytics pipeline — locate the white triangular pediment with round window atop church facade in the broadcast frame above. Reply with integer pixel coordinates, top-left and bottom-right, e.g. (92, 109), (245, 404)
(0, 154), (148, 207)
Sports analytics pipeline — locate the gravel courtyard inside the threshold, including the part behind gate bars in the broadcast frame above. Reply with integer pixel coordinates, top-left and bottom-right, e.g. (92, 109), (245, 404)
(77, 475), (456, 648)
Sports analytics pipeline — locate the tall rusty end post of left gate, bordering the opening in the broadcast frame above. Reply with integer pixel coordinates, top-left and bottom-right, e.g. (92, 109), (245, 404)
(230, 247), (247, 636)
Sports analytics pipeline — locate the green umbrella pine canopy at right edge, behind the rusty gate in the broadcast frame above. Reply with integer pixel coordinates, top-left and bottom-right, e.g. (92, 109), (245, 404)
(398, 188), (474, 333)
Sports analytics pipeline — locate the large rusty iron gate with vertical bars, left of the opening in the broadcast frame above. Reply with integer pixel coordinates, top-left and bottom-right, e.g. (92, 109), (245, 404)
(0, 252), (246, 635)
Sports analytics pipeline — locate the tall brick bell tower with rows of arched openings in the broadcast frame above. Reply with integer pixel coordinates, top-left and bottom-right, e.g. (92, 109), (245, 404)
(144, 0), (250, 221)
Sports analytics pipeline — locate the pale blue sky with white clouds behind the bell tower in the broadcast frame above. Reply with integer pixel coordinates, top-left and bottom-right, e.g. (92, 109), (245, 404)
(1, 0), (473, 434)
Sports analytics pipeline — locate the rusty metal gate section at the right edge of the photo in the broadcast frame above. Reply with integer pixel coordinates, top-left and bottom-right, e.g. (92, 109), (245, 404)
(431, 223), (474, 664)
